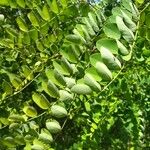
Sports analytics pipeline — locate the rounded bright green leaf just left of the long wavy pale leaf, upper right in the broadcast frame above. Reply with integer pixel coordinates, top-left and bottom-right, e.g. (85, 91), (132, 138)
(103, 23), (121, 39)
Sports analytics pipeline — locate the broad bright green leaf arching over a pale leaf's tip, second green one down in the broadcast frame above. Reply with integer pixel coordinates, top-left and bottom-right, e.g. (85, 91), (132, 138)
(96, 38), (118, 54)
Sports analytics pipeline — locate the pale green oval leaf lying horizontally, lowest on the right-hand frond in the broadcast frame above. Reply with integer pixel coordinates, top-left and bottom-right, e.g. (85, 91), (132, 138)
(71, 84), (92, 95)
